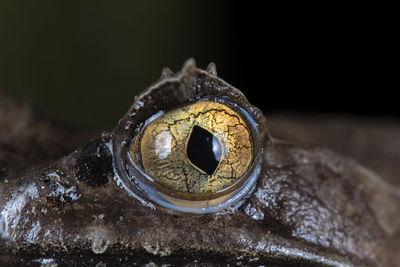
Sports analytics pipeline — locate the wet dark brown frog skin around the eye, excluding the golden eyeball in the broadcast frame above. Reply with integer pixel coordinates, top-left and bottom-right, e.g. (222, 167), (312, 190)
(0, 60), (400, 266)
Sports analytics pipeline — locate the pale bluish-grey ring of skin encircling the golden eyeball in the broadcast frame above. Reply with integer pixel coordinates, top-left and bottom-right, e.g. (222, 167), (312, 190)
(113, 96), (262, 214)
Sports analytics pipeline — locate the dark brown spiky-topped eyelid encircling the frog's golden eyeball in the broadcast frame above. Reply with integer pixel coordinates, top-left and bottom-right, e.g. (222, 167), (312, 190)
(108, 59), (272, 213)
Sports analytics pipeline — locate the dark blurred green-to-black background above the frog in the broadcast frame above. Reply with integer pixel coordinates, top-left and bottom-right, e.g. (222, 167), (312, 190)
(0, 1), (400, 128)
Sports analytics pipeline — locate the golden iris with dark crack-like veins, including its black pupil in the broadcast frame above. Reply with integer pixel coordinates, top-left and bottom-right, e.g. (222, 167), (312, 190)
(130, 101), (253, 194)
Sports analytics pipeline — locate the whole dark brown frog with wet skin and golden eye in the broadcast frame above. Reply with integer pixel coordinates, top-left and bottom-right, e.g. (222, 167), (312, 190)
(0, 59), (400, 266)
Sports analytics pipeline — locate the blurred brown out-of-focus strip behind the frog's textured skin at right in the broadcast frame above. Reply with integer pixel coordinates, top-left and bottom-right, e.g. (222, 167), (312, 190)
(267, 114), (400, 185)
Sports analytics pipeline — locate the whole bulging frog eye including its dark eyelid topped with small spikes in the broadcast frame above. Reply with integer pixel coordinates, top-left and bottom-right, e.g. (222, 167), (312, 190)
(110, 60), (264, 213)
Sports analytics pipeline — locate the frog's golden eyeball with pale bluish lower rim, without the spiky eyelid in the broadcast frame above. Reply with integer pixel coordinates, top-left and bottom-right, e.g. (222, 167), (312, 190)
(120, 99), (259, 213)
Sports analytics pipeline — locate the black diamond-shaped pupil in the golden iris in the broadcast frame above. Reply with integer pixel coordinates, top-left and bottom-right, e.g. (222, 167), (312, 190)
(186, 125), (222, 175)
